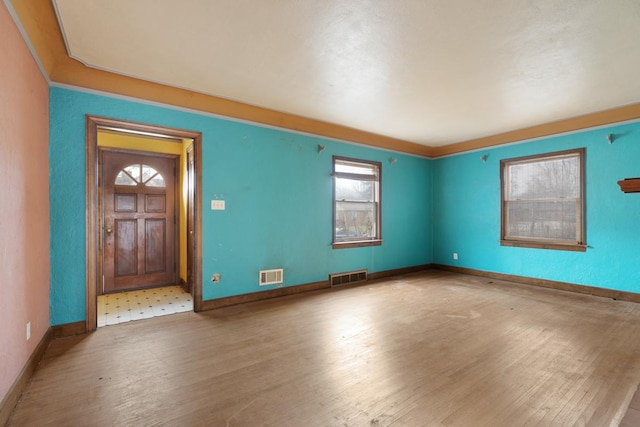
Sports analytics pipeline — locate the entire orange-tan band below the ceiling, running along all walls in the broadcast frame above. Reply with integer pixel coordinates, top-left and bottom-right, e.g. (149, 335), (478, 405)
(10, 0), (640, 158)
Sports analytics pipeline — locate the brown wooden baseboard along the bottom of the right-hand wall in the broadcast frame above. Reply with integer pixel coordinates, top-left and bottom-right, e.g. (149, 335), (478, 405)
(433, 264), (640, 303)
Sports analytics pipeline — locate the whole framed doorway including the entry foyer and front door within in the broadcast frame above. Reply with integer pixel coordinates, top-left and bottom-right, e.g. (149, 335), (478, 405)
(86, 116), (202, 331)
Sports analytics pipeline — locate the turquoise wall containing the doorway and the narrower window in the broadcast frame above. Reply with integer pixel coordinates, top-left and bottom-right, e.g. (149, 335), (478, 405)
(49, 87), (433, 325)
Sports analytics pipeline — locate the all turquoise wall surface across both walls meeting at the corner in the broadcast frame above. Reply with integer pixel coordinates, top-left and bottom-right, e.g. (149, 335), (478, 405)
(49, 88), (640, 325)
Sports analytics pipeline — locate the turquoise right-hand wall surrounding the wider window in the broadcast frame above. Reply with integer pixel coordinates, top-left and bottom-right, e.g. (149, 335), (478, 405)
(433, 123), (640, 292)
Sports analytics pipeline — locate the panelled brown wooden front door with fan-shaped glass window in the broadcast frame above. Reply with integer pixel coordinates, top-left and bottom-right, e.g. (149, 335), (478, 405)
(101, 150), (177, 293)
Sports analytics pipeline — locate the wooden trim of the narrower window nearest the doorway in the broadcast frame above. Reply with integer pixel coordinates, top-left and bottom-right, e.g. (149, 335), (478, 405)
(331, 156), (382, 249)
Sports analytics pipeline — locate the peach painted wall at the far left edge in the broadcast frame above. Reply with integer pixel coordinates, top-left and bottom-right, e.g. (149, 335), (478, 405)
(0, 2), (50, 401)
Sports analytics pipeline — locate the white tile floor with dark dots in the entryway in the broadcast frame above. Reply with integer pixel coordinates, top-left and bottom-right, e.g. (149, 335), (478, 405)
(98, 286), (193, 328)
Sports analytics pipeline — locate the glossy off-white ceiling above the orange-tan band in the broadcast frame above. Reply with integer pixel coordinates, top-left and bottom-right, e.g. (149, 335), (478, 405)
(53, 0), (640, 146)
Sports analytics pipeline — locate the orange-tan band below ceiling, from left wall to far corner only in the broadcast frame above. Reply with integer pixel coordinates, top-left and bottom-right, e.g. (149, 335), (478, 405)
(8, 0), (431, 157)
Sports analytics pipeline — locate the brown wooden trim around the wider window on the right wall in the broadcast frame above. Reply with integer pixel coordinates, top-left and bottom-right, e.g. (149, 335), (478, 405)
(500, 148), (587, 252)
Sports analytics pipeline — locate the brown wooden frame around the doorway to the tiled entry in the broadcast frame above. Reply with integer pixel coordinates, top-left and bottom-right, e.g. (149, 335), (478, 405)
(85, 115), (202, 332)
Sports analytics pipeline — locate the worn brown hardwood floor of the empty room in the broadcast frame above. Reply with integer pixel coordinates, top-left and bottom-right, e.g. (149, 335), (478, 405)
(9, 270), (640, 427)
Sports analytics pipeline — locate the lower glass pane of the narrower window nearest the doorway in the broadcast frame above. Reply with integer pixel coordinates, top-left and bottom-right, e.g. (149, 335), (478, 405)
(335, 201), (377, 240)
